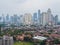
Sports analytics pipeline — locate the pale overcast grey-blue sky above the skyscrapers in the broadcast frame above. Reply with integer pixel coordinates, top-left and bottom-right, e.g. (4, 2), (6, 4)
(0, 0), (60, 16)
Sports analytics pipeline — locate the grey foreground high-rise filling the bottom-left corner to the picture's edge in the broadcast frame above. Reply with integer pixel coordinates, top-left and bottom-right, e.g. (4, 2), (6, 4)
(0, 35), (14, 45)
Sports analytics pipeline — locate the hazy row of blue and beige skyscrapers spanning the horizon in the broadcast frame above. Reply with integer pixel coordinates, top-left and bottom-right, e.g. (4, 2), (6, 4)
(0, 8), (59, 26)
